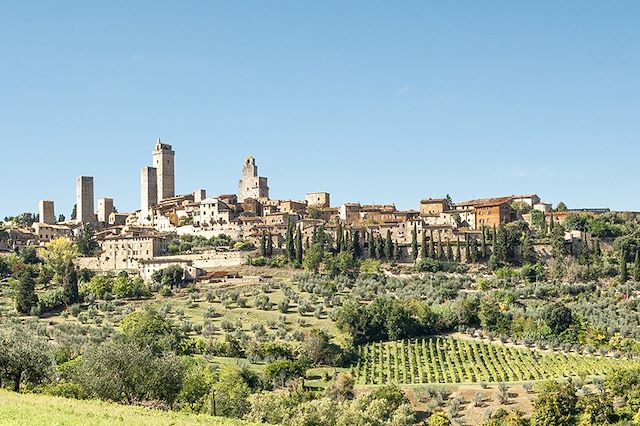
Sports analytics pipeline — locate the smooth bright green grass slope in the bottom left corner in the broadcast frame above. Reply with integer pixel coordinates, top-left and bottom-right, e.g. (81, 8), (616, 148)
(0, 390), (256, 426)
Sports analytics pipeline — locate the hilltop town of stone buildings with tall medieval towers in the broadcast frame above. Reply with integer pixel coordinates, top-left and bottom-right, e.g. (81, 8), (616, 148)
(3, 139), (608, 280)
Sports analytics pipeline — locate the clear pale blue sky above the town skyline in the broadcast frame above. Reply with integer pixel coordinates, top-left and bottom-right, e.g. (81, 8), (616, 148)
(0, 0), (640, 217)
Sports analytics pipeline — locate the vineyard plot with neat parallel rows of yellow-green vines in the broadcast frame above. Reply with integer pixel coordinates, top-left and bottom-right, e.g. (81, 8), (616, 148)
(353, 336), (640, 385)
